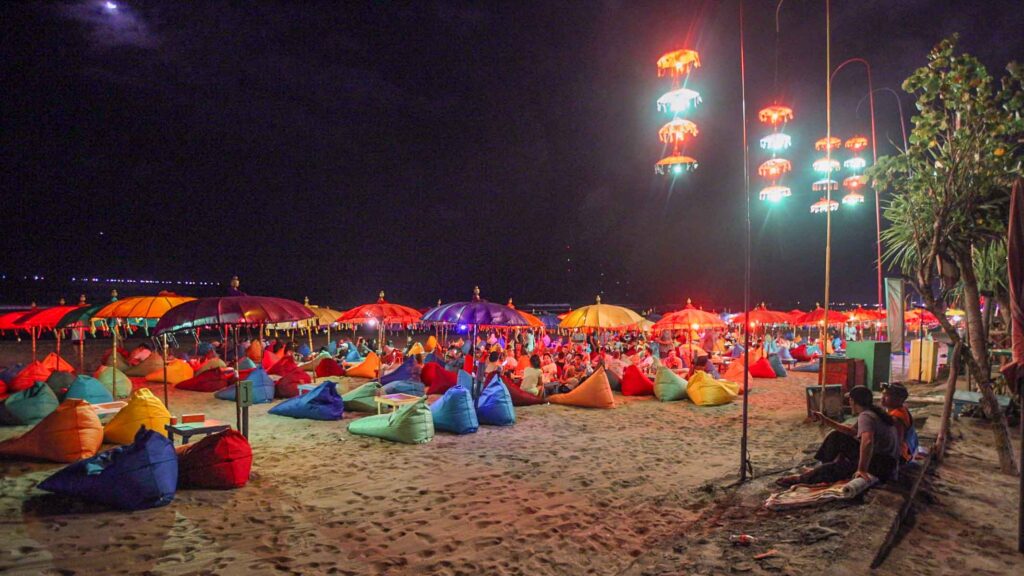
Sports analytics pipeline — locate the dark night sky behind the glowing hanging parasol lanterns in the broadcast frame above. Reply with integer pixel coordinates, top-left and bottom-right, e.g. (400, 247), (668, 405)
(0, 0), (1024, 307)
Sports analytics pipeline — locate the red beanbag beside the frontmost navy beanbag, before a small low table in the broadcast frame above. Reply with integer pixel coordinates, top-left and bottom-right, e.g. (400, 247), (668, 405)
(177, 429), (253, 490)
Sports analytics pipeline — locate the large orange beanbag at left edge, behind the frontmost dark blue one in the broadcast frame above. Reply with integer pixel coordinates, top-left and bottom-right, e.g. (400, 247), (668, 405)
(0, 399), (103, 462)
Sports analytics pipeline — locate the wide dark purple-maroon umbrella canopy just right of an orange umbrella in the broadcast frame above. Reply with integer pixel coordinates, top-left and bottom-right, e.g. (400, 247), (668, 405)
(156, 296), (316, 335)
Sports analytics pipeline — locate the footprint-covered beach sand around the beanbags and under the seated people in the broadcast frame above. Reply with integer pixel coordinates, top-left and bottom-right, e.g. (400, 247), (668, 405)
(0, 336), (1024, 575)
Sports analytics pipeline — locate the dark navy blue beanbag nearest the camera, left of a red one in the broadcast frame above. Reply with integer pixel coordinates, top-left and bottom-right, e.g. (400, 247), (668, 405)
(39, 428), (178, 510)
